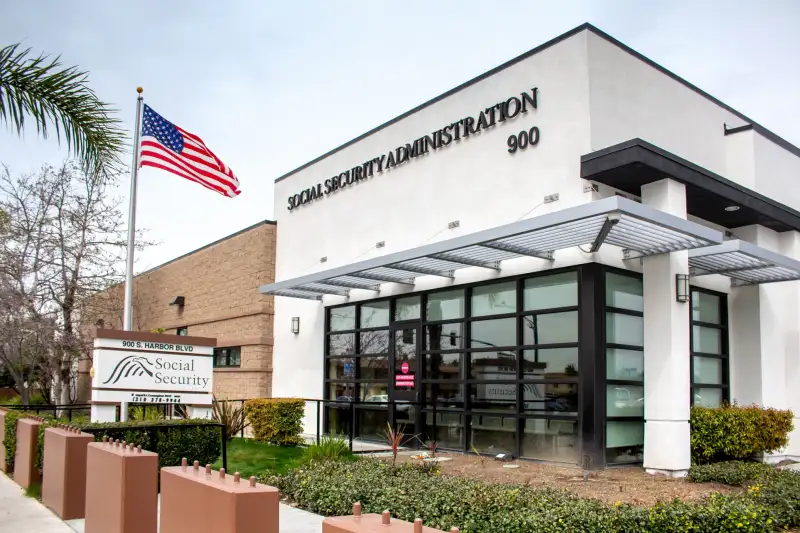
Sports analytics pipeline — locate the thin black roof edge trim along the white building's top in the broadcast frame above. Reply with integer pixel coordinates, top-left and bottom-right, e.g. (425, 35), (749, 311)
(275, 22), (800, 183)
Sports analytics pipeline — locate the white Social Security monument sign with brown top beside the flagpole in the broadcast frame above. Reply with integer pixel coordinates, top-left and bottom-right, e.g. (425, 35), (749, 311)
(92, 329), (217, 422)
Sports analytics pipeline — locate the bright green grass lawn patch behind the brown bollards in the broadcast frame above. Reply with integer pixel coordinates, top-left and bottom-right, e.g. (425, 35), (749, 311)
(213, 438), (304, 478)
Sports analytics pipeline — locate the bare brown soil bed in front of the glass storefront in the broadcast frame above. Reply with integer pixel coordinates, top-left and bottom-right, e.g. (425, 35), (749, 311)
(397, 453), (741, 506)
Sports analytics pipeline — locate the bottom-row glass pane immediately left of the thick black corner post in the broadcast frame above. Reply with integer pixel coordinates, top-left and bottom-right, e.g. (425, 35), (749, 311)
(521, 418), (580, 463)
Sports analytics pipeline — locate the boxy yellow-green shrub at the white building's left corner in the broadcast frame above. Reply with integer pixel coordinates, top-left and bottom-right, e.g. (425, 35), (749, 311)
(244, 398), (306, 446)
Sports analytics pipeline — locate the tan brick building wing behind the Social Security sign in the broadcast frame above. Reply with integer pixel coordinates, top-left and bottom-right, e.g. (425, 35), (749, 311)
(79, 220), (276, 399)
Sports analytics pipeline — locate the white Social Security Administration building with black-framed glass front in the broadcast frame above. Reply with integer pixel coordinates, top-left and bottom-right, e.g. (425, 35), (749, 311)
(261, 25), (800, 475)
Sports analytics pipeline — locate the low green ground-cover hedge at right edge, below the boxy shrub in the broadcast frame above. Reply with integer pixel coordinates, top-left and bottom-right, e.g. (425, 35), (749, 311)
(689, 461), (800, 529)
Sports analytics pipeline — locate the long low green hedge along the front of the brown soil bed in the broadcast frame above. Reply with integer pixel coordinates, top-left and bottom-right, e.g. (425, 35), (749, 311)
(261, 459), (776, 533)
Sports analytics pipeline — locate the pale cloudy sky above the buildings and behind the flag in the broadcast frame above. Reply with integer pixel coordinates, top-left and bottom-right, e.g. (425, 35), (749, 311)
(0, 0), (800, 272)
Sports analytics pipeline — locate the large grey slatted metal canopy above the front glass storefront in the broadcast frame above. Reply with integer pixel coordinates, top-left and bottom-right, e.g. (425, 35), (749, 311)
(260, 197), (722, 300)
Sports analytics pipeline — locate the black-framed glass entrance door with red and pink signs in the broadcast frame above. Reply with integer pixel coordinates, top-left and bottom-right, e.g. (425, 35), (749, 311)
(389, 322), (421, 434)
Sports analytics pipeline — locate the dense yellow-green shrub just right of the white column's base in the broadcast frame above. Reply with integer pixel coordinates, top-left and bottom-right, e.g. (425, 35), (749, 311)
(690, 405), (793, 464)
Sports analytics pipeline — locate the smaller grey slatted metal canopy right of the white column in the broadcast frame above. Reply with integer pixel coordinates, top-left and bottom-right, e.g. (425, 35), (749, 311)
(689, 240), (800, 285)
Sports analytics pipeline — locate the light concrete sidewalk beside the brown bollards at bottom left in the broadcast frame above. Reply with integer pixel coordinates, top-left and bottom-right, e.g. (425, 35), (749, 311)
(0, 473), (323, 533)
